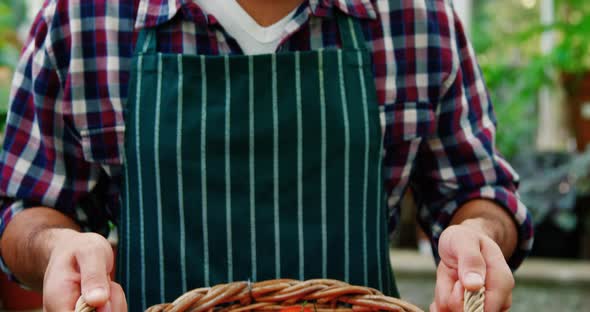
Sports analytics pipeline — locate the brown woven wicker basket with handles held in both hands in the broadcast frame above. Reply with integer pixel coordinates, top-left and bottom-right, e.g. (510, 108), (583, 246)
(76, 279), (483, 312)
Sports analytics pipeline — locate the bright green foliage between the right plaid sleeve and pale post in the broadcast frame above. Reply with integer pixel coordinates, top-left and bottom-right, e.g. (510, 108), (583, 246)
(470, 0), (544, 159)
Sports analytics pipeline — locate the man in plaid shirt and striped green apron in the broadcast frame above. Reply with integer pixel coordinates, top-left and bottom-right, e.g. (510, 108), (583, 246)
(0, 0), (532, 311)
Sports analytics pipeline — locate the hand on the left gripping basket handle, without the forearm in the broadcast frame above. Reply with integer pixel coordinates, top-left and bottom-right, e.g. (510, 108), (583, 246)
(40, 229), (127, 312)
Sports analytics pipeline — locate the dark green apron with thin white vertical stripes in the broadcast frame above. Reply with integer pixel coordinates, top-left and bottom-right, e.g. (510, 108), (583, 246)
(118, 14), (397, 311)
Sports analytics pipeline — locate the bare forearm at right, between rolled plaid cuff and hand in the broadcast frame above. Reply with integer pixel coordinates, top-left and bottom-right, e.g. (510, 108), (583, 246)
(451, 199), (518, 259)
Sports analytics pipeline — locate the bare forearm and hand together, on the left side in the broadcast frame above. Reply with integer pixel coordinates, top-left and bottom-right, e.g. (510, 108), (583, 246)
(0, 207), (127, 312)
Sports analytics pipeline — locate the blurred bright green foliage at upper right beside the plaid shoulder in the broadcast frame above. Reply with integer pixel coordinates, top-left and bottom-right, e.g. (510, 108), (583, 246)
(471, 0), (590, 159)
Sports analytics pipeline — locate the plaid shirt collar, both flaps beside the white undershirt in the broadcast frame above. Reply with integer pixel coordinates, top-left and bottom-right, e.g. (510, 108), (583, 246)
(135, 0), (377, 29)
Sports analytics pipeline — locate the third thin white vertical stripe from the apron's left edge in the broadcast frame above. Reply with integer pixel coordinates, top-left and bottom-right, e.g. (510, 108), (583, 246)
(176, 54), (187, 293)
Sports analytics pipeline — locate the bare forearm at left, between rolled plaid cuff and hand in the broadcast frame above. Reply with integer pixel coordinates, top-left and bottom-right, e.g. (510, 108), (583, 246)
(0, 207), (79, 289)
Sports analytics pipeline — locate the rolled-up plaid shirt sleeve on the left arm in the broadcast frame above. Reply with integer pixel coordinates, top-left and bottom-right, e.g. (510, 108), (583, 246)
(0, 1), (117, 271)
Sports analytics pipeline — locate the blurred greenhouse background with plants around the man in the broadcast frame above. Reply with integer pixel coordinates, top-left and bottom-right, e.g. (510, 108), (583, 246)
(0, 0), (590, 311)
